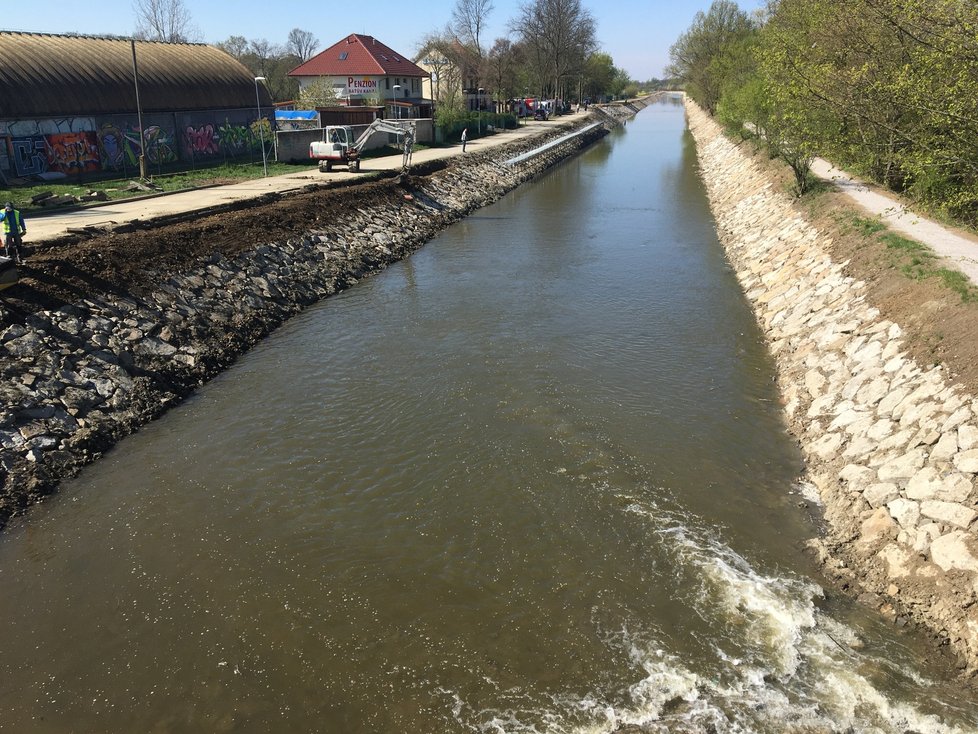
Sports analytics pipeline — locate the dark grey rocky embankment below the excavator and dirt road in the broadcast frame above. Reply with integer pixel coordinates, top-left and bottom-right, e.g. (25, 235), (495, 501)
(0, 103), (656, 526)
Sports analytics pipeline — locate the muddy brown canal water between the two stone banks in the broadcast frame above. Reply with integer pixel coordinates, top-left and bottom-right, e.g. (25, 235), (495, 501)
(0, 100), (978, 733)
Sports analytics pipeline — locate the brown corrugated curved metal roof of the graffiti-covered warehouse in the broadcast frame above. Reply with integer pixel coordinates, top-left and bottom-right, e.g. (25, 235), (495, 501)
(0, 31), (272, 120)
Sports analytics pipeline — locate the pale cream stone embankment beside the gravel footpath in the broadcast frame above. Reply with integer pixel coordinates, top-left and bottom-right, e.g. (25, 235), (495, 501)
(687, 103), (978, 675)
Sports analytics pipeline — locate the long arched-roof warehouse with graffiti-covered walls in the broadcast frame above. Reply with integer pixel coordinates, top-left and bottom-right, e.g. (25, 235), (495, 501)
(0, 31), (272, 183)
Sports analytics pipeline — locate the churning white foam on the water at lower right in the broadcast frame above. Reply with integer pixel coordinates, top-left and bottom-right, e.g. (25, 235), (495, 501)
(462, 504), (976, 734)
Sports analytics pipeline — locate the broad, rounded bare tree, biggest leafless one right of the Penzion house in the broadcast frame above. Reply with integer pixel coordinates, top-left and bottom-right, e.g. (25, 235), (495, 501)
(511, 0), (597, 97)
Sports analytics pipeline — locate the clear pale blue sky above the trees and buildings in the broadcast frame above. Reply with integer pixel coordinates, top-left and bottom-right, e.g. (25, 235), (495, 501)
(9, 0), (764, 80)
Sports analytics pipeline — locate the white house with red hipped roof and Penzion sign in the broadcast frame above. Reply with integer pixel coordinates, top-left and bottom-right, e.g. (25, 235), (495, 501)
(289, 33), (432, 119)
